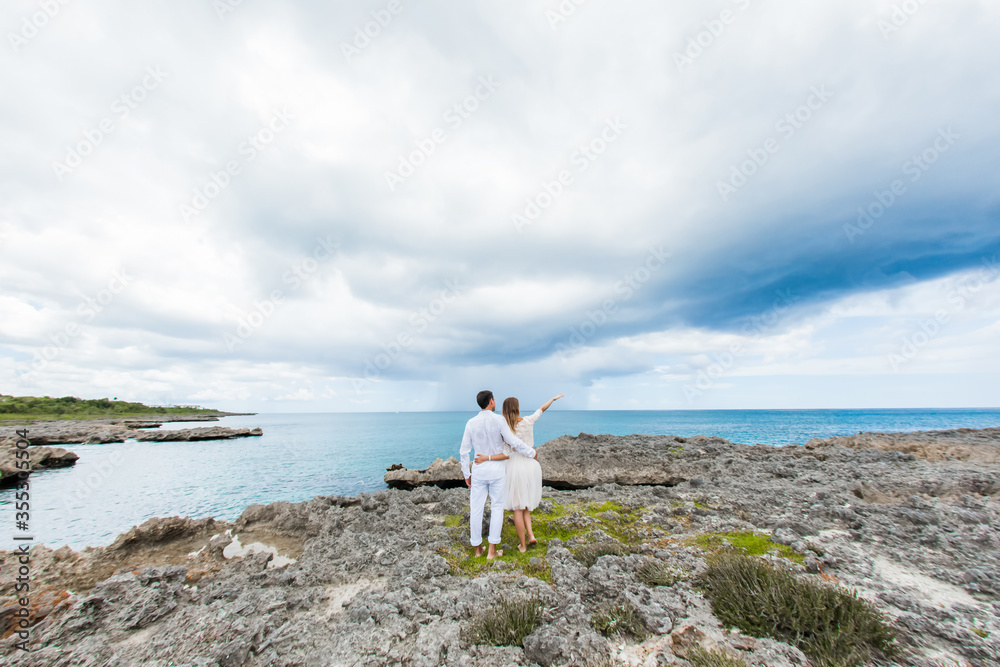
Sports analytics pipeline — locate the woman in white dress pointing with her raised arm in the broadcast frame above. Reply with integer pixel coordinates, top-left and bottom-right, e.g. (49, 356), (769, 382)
(484, 394), (563, 553)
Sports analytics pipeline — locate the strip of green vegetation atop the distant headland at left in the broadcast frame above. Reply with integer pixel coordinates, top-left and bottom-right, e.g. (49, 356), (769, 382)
(0, 394), (221, 420)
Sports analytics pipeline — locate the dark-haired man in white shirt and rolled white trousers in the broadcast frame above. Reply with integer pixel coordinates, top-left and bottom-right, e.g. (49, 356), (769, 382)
(460, 391), (536, 560)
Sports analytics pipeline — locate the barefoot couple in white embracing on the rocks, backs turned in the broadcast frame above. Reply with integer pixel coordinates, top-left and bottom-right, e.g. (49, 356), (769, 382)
(460, 391), (562, 560)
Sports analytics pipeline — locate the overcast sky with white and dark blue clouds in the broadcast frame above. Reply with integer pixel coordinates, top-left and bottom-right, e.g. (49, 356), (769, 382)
(0, 0), (1000, 412)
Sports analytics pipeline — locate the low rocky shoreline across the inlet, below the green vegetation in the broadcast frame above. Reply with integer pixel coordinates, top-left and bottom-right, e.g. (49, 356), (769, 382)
(0, 415), (263, 487)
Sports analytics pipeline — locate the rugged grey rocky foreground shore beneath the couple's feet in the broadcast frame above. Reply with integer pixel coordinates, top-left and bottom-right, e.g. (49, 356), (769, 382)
(0, 429), (1000, 667)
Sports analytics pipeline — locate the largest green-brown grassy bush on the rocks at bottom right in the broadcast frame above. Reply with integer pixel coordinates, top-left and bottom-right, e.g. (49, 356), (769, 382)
(697, 551), (897, 667)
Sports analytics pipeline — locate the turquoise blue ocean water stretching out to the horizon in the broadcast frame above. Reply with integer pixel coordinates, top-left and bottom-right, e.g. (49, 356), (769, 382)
(0, 409), (1000, 549)
